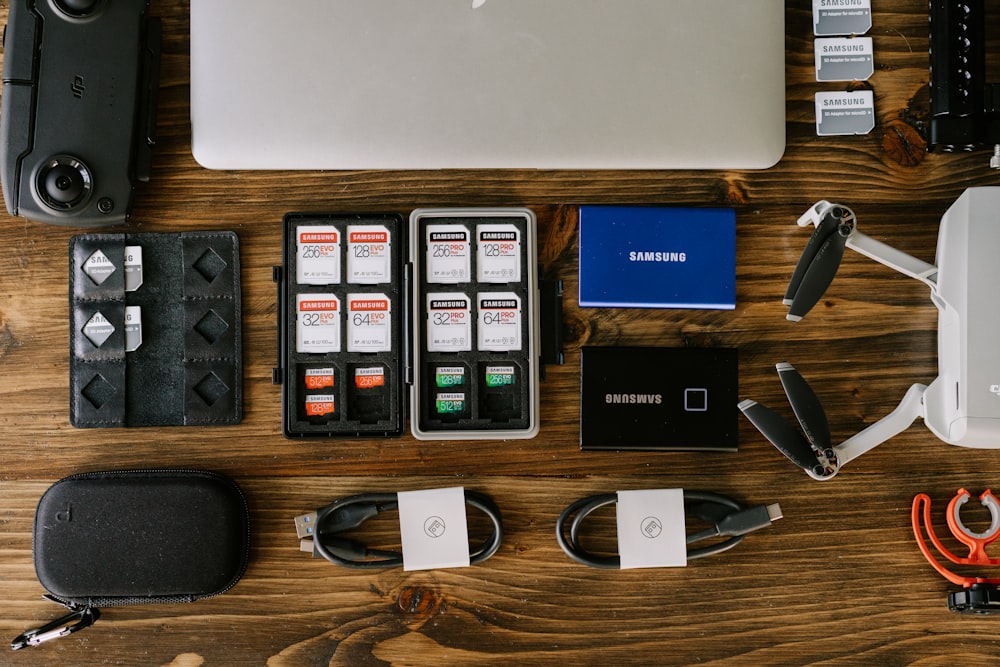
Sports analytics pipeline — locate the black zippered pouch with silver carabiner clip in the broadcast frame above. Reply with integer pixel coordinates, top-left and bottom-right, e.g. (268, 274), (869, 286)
(12, 470), (250, 649)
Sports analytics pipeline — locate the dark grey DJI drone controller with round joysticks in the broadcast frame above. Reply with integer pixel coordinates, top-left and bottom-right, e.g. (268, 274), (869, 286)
(0, 0), (161, 227)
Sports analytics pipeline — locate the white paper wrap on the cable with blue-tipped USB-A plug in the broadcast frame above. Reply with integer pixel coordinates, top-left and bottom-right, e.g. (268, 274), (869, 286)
(396, 486), (469, 571)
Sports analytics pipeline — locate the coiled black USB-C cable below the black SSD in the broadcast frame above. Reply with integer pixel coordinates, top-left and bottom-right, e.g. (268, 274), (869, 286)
(556, 490), (782, 570)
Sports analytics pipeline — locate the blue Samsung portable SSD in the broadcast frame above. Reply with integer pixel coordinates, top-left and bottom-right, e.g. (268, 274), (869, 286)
(580, 206), (736, 310)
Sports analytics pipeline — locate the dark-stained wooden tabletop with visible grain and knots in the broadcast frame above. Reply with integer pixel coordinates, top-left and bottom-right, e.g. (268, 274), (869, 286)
(0, 0), (1000, 667)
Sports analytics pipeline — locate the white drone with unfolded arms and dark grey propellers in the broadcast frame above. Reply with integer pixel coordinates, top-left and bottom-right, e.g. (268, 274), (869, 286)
(739, 187), (1000, 479)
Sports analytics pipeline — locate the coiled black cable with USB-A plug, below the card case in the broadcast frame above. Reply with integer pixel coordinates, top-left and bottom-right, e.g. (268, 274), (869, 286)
(295, 489), (503, 570)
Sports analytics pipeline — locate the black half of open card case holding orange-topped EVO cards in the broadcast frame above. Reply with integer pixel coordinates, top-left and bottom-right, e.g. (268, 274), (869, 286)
(273, 213), (409, 438)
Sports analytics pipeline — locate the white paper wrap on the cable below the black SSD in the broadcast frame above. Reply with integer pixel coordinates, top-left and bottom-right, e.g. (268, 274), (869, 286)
(616, 489), (687, 570)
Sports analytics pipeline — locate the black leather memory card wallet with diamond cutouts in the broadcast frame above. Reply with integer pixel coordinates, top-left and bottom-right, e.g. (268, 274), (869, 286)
(69, 232), (243, 427)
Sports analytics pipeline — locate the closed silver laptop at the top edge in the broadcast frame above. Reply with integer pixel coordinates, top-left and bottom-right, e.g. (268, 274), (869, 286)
(191, 0), (785, 169)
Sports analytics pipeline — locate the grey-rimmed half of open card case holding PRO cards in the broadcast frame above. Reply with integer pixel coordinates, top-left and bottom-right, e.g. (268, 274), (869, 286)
(410, 208), (539, 440)
